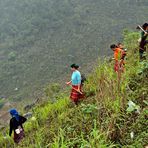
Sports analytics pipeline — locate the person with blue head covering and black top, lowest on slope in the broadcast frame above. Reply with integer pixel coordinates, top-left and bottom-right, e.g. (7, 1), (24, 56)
(9, 109), (27, 143)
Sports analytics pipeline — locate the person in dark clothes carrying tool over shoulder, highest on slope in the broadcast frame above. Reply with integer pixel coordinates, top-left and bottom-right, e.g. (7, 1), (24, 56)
(139, 23), (148, 60)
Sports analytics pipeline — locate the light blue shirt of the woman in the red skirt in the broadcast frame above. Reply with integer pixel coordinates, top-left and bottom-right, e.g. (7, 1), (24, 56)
(71, 70), (81, 85)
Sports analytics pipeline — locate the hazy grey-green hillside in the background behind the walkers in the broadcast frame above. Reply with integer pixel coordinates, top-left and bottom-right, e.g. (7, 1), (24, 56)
(0, 0), (148, 99)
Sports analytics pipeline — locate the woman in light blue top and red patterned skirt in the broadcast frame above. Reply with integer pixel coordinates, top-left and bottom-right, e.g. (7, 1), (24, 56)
(66, 64), (84, 105)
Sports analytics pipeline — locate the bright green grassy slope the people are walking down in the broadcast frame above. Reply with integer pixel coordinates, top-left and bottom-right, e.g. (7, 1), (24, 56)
(0, 31), (148, 148)
